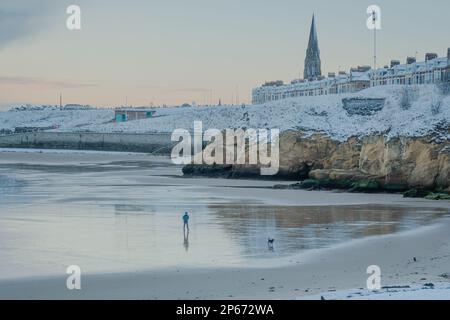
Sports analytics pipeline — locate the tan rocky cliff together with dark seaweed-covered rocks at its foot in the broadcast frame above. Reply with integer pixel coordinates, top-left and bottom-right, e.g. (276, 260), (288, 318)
(184, 131), (450, 192)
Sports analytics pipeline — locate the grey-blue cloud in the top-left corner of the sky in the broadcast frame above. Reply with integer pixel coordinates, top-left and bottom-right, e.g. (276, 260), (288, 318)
(0, 0), (51, 48)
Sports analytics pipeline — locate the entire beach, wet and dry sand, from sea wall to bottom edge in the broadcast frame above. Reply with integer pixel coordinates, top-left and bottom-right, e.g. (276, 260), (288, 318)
(0, 150), (450, 299)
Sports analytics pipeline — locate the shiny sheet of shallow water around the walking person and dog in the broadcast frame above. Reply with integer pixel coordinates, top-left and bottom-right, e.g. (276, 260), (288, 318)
(0, 155), (448, 279)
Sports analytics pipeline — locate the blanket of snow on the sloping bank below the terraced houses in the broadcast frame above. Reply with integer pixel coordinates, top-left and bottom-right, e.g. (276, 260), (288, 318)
(0, 85), (450, 140)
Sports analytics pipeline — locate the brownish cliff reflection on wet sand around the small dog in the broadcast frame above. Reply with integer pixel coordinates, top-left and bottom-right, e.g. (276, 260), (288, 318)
(209, 205), (448, 257)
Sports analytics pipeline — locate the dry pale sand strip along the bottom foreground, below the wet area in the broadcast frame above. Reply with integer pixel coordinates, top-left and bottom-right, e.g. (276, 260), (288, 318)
(0, 220), (450, 300)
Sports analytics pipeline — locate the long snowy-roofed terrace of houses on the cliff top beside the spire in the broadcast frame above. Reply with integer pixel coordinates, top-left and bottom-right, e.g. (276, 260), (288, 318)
(252, 48), (450, 104)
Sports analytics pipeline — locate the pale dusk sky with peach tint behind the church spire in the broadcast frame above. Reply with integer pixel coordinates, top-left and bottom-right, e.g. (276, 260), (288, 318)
(0, 0), (450, 107)
